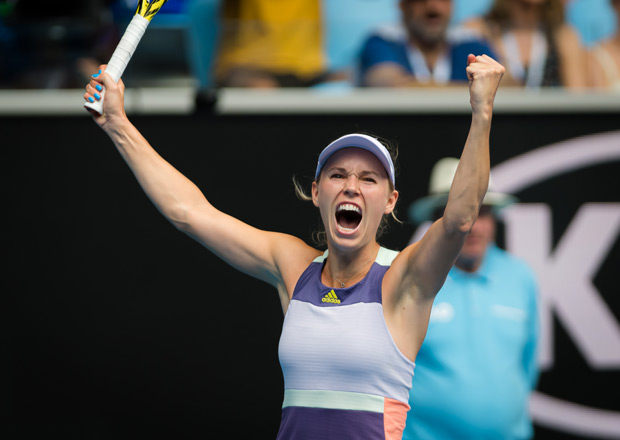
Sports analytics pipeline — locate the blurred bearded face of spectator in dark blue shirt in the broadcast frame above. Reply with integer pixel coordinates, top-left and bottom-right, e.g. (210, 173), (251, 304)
(400, 0), (452, 46)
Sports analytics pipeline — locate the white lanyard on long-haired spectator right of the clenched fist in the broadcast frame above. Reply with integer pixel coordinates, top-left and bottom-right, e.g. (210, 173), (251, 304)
(502, 30), (548, 87)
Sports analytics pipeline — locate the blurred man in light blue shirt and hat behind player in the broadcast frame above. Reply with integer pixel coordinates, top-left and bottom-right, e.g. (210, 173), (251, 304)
(403, 158), (539, 440)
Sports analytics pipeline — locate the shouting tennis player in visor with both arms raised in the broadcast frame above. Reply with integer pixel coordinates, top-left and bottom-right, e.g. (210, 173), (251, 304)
(84, 55), (504, 440)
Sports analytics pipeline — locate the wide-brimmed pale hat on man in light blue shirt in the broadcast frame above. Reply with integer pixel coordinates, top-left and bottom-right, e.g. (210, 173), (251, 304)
(408, 157), (518, 223)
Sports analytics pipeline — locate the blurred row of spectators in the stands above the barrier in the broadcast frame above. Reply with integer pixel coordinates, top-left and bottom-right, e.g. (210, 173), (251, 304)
(0, 0), (620, 90)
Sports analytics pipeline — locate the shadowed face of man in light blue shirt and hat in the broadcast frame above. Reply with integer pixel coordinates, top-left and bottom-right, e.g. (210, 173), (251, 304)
(456, 206), (496, 270)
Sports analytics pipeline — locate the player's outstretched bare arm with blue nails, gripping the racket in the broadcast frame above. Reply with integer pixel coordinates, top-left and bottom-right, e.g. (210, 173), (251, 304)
(84, 68), (316, 306)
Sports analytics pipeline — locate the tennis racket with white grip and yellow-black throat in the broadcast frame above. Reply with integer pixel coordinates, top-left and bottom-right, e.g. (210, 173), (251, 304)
(84, 0), (168, 115)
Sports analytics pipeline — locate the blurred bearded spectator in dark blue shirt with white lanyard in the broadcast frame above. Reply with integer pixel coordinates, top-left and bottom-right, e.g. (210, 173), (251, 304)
(360, 0), (495, 87)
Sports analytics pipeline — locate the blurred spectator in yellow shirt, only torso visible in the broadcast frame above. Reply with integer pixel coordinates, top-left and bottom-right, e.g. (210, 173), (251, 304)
(215, 0), (344, 88)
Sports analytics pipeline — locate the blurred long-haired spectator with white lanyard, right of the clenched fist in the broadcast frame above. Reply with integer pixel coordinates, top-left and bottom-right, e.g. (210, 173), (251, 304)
(464, 0), (586, 88)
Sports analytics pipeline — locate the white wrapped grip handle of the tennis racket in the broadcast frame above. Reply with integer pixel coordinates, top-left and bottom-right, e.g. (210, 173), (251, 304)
(84, 14), (150, 115)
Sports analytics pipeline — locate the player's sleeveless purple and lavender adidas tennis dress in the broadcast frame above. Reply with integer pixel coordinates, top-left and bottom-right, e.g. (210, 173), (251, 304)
(277, 248), (414, 440)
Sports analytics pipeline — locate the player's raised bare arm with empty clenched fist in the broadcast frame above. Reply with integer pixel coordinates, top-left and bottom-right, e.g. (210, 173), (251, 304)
(384, 55), (504, 358)
